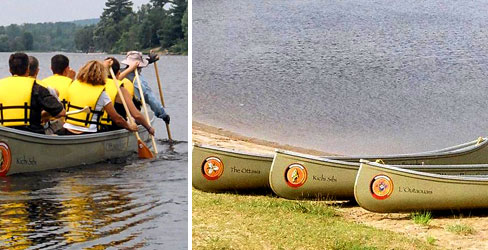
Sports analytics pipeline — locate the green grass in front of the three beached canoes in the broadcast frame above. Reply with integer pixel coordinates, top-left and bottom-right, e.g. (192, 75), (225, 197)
(192, 189), (434, 250)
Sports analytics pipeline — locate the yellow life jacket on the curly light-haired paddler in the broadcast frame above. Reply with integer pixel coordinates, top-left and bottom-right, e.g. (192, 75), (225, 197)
(66, 81), (105, 128)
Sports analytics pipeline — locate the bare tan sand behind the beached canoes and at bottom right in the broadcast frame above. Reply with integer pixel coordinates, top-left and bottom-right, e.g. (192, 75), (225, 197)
(192, 122), (488, 249)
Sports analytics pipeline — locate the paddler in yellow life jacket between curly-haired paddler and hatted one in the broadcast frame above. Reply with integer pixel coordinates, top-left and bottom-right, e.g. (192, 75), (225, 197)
(100, 57), (155, 135)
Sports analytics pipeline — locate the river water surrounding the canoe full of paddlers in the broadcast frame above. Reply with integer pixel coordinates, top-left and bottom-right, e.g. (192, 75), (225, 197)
(0, 53), (188, 249)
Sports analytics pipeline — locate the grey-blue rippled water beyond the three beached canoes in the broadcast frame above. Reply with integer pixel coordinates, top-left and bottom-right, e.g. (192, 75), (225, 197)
(192, 0), (488, 154)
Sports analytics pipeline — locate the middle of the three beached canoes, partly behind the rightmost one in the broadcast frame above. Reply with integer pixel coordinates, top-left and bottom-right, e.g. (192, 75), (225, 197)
(269, 138), (488, 199)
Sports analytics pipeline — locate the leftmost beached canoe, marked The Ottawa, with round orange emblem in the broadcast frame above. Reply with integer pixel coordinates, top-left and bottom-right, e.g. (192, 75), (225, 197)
(192, 144), (273, 192)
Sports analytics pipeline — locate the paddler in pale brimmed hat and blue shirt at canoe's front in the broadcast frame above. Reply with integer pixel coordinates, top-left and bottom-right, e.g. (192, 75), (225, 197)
(121, 51), (170, 124)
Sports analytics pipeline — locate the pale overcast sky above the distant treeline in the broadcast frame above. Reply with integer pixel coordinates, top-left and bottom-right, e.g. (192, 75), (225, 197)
(0, 0), (149, 25)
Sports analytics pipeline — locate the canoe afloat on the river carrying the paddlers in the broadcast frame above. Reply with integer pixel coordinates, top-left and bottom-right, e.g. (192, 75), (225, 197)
(0, 123), (148, 176)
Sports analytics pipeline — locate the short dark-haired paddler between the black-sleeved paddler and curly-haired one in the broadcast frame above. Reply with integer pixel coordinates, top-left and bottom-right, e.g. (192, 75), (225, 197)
(41, 54), (76, 108)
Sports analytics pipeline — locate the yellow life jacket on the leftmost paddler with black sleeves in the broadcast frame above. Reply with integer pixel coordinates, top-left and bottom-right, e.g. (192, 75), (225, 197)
(0, 76), (35, 127)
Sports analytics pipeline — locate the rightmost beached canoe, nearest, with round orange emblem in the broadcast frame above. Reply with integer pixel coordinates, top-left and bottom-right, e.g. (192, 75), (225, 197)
(354, 160), (488, 213)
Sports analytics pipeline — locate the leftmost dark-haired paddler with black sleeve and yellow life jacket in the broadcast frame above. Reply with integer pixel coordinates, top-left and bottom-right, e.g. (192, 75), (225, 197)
(0, 53), (66, 134)
